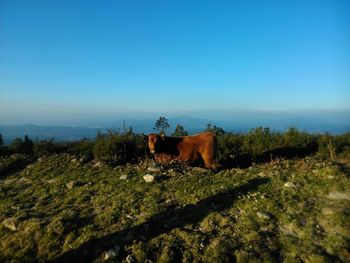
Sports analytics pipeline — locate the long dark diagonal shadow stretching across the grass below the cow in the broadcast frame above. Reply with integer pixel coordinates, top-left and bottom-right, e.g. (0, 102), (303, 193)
(53, 178), (269, 262)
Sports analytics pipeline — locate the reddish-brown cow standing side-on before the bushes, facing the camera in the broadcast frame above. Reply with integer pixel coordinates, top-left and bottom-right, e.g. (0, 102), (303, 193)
(148, 132), (216, 169)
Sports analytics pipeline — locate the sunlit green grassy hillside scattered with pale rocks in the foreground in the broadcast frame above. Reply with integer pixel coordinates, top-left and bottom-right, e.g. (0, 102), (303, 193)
(0, 154), (350, 262)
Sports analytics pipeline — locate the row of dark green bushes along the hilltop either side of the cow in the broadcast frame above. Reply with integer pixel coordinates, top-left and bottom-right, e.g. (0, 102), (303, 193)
(0, 128), (350, 168)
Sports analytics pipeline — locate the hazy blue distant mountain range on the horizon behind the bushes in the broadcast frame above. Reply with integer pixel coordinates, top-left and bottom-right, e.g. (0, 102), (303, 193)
(0, 116), (350, 144)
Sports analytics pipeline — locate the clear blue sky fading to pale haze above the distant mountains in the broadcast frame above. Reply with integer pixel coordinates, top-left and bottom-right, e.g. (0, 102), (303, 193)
(0, 0), (350, 124)
